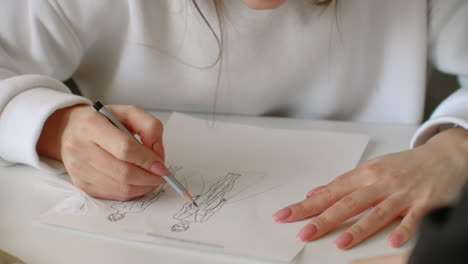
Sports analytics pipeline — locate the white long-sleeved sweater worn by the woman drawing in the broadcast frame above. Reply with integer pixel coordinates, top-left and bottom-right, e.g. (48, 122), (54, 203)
(0, 0), (468, 171)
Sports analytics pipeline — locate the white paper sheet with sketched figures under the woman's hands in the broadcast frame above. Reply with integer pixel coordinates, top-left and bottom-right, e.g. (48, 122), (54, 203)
(40, 113), (369, 262)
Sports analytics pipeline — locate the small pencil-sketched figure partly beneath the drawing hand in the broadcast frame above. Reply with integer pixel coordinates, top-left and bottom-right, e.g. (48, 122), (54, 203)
(107, 185), (166, 222)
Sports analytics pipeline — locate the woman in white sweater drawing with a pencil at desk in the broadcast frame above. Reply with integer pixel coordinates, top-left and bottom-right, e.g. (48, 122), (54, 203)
(0, 0), (468, 252)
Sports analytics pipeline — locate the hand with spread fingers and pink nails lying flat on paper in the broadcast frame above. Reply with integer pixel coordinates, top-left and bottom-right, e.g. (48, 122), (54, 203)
(273, 128), (468, 249)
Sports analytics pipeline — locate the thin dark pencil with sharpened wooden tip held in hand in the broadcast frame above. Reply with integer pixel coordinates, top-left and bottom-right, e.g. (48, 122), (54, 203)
(93, 101), (198, 207)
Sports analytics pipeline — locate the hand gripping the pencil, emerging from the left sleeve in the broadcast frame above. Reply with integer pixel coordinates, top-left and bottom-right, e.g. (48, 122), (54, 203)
(37, 105), (168, 200)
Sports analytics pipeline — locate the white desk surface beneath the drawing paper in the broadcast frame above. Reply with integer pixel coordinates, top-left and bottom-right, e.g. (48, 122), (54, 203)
(0, 113), (416, 264)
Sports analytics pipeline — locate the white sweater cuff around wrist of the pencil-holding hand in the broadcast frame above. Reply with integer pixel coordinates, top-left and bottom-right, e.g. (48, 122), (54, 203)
(0, 88), (91, 173)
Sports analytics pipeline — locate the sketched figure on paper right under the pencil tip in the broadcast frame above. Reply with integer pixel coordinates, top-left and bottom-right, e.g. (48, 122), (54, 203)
(171, 173), (241, 232)
